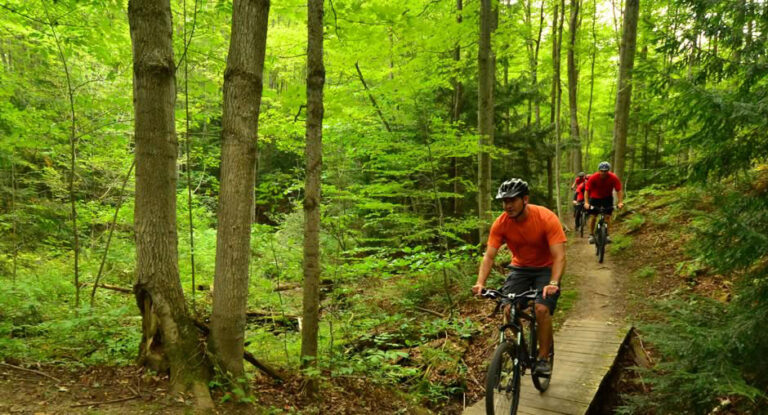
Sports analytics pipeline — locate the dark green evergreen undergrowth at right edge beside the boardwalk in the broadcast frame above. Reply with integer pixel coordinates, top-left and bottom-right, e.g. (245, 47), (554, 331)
(620, 184), (768, 414)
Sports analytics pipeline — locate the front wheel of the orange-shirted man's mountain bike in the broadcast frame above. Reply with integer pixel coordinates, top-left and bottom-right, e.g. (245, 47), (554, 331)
(485, 341), (521, 415)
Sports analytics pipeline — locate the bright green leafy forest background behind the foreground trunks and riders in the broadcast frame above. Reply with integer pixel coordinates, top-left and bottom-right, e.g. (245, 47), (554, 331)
(0, 0), (768, 413)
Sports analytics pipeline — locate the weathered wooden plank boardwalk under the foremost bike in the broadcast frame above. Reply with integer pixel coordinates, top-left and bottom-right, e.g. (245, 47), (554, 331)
(463, 320), (629, 415)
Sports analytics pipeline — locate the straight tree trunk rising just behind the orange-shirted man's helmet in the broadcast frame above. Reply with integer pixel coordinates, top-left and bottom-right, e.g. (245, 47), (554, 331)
(477, 0), (495, 243)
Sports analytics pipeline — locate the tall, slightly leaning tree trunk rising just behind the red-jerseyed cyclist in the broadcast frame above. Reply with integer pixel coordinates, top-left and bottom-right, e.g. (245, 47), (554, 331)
(613, 0), (640, 177)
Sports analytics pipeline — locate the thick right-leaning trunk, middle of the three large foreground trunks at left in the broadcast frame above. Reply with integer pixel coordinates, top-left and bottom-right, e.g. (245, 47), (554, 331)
(209, 0), (269, 378)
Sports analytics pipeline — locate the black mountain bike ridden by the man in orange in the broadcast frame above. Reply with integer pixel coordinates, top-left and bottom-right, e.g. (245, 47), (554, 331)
(481, 289), (555, 415)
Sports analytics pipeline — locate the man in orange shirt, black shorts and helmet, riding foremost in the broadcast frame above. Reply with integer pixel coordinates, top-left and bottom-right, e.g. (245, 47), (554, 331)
(472, 179), (566, 375)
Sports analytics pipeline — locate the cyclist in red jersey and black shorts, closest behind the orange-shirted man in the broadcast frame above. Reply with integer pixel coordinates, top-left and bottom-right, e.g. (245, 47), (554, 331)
(584, 161), (624, 244)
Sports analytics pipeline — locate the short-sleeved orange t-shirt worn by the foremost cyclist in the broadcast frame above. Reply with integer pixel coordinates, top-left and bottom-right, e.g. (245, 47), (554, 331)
(488, 204), (567, 267)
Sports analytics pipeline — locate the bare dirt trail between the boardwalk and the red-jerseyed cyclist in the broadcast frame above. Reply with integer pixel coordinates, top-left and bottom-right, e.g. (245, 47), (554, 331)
(565, 234), (624, 320)
